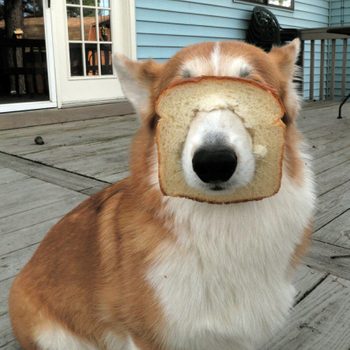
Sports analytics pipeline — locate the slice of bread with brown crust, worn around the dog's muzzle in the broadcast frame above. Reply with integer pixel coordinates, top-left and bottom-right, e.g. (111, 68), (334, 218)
(156, 77), (285, 203)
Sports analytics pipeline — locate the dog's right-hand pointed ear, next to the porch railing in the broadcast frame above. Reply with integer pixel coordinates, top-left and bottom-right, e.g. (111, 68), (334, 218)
(269, 39), (300, 80)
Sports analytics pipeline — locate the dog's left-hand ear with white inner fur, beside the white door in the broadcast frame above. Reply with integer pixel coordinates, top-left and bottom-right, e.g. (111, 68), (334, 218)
(114, 54), (163, 114)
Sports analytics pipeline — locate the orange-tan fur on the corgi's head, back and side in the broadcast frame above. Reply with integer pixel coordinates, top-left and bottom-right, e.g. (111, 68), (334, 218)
(9, 42), (312, 350)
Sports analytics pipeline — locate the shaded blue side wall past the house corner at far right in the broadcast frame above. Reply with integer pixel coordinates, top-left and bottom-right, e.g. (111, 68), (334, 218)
(330, 0), (350, 98)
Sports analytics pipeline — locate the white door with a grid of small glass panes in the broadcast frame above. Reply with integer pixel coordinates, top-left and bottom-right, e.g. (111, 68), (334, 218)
(51, 0), (136, 107)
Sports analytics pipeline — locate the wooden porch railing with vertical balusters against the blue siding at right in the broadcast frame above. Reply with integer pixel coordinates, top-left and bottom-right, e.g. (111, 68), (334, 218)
(301, 27), (350, 101)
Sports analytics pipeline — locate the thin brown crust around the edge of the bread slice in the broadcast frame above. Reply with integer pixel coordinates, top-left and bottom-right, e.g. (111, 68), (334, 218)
(155, 76), (286, 204)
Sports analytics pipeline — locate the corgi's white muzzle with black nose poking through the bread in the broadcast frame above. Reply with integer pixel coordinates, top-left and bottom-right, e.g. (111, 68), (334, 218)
(182, 109), (255, 193)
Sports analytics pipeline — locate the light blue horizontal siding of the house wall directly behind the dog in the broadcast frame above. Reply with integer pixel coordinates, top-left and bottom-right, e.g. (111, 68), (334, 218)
(136, 0), (330, 96)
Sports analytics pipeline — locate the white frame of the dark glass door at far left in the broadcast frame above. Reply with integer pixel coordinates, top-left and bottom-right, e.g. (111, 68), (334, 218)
(0, 0), (57, 113)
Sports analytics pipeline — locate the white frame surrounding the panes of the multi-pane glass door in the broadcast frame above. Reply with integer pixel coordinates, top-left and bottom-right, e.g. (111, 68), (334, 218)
(52, 0), (136, 108)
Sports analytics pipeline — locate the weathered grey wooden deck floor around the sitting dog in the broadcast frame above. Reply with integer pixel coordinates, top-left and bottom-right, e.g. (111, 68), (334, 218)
(0, 104), (350, 350)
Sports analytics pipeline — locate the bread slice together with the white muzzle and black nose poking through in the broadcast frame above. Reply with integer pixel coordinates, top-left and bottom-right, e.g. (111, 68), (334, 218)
(156, 77), (285, 203)
